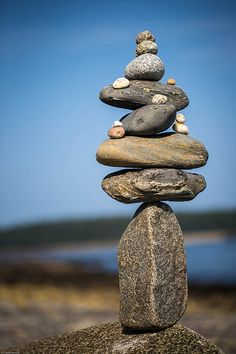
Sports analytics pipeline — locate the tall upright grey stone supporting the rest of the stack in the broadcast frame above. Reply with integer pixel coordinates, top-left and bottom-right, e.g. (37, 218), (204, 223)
(118, 203), (188, 331)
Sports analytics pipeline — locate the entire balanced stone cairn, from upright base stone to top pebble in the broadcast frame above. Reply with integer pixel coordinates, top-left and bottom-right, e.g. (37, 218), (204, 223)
(97, 31), (208, 332)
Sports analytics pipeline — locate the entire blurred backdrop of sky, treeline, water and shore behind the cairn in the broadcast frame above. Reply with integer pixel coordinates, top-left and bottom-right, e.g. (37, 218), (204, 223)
(0, 0), (236, 353)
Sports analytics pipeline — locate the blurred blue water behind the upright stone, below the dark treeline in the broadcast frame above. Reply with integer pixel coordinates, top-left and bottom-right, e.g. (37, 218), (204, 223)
(0, 237), (236, 284)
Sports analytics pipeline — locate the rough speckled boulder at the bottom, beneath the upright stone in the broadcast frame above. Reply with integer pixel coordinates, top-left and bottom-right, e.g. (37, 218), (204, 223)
(3, 322), (224, 354)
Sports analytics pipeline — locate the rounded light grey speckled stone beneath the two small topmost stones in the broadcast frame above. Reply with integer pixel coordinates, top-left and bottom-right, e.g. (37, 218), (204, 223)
(125, 54), (165, 81)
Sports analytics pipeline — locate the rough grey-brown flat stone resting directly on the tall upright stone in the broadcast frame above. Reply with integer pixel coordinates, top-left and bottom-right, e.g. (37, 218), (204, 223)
(102, 168), (206, 204)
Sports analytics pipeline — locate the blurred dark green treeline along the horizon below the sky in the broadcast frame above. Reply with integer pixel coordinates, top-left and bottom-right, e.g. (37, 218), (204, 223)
(0, 210), (236, 248)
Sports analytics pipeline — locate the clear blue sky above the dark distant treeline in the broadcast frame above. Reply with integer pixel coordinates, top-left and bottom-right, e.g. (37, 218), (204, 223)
(0, 0), (236, 227)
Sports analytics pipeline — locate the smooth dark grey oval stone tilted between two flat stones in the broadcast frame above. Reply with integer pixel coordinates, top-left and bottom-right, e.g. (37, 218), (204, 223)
(121, 104), (176, 136)
